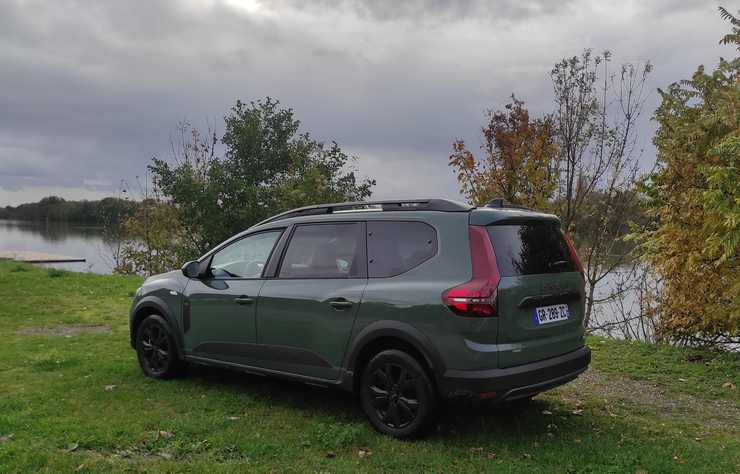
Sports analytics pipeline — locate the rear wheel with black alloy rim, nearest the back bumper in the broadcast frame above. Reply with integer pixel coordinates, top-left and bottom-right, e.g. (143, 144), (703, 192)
(360, 349), (438, 438)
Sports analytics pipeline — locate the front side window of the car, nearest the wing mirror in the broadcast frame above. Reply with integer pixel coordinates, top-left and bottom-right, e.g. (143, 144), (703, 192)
(211, 230), (282, 279)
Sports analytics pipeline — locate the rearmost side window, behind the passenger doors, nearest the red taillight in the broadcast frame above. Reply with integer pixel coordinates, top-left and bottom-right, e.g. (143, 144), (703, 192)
(367, 221), (437, 278)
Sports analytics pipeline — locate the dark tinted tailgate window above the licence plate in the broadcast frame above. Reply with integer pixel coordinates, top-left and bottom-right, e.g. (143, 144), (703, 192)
(488, 222), (577, 276)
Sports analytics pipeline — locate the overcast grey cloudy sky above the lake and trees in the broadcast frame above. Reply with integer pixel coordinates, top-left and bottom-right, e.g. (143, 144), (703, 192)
(0, 0), (734, 205)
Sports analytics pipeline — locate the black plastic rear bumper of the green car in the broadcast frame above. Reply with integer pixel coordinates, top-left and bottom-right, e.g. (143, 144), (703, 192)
(438, 346), (591, 400)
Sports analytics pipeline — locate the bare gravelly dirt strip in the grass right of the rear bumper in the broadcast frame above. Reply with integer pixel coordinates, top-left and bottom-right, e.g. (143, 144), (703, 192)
(561, 369), (740, 432)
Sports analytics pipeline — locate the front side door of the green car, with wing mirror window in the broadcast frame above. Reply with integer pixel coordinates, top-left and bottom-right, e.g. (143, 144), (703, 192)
(183, 230), (283, 365)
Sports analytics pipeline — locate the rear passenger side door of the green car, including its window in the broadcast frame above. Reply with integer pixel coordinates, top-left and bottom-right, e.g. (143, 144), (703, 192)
(257, 222), (367, 380)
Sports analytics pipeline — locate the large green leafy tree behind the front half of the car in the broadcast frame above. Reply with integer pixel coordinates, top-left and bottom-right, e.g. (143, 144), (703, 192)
(121, 97), (375, 273)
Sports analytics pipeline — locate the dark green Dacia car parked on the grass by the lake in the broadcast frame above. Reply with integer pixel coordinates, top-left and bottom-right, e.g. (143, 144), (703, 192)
(130, 199), (591, 438)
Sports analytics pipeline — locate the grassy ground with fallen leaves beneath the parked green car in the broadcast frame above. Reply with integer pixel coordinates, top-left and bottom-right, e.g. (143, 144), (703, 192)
(0, 262), (740, 473)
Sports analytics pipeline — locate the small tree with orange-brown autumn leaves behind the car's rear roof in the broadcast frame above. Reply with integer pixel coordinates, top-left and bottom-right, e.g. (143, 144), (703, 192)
(449, 95), (557, 209)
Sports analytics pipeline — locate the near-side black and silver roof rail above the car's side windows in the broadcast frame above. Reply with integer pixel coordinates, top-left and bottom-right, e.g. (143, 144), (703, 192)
(252, 199), (473, 227)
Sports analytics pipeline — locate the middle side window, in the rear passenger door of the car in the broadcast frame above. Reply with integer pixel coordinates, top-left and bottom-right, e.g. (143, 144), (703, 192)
(279, 222), (367, 278)
